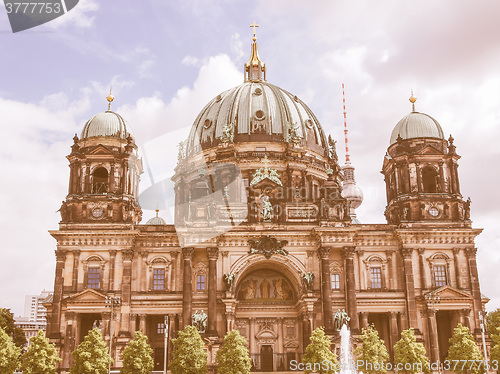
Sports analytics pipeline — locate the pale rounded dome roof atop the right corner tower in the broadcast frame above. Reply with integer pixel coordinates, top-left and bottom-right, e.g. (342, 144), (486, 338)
(391, 112), (444, 144)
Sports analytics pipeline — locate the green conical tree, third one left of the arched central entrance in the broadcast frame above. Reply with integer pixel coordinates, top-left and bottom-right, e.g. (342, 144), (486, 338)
(121, 331), (155, 374)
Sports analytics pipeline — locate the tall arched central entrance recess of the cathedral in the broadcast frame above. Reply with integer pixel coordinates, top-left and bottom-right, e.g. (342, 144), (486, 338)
(235, 261), (302, 372)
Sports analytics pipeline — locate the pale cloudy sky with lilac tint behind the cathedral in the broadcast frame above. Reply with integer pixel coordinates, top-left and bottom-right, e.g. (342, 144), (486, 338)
(0, 0), (500, 315)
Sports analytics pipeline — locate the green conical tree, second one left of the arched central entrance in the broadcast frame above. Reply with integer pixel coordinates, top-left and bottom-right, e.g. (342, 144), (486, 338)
(170, 325), (207, 374)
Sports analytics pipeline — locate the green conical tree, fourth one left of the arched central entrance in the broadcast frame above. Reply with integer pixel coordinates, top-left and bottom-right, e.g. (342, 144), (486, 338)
(70, 327), (110, 374)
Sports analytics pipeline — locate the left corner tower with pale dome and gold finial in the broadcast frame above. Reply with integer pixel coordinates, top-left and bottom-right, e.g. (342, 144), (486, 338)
(60, 93), (142, 224)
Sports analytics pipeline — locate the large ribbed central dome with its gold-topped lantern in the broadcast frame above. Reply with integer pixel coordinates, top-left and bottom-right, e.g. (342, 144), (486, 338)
(185, 36), (328, 156)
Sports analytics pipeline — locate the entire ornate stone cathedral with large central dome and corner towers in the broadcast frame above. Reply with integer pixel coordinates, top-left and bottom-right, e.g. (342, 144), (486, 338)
(46, 28), (488, 372)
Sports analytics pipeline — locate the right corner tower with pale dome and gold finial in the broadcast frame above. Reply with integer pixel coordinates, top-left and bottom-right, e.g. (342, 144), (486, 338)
(382, 94), (470, 225)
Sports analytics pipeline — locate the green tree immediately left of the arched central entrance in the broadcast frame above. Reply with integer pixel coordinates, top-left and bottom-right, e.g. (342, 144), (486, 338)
(215, 330), (252, 374)
